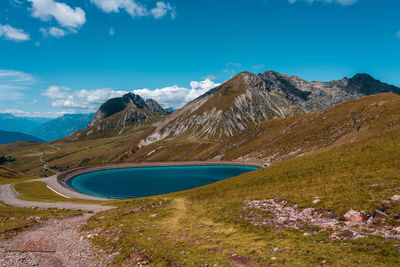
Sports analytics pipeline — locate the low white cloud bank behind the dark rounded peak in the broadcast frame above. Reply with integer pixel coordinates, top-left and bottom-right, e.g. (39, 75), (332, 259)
(42, 79), (219, 113)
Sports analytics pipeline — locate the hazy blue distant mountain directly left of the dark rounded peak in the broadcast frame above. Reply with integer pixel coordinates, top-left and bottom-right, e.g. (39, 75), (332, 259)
(29, 113), (94, 141)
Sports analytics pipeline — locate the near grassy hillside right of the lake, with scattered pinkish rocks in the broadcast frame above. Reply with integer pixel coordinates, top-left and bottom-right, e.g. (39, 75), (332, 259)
(83, 108), (400, 266)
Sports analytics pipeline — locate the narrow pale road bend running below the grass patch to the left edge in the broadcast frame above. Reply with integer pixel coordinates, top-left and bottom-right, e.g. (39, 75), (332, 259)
(0, 184), (114, 212)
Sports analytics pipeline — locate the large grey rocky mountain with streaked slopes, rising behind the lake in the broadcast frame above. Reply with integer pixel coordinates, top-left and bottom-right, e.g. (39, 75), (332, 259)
(143, 71), (400, 142)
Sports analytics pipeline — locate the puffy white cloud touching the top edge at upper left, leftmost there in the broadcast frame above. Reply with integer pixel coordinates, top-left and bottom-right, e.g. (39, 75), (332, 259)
(28, 0), (86, 30)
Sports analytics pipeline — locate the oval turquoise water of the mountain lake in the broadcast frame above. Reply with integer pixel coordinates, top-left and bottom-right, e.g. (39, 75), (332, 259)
(67, 165), (258, 199)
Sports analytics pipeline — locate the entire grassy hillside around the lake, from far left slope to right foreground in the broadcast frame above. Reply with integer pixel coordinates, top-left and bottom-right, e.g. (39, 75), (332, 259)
(0, 93), (400, 266)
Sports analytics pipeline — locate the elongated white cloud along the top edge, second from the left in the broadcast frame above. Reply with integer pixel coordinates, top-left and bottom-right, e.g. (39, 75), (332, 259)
(90, 0), (176, 19)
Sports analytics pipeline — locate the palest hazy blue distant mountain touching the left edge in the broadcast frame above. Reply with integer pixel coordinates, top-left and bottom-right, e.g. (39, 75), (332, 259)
(0, 113), (51, 134)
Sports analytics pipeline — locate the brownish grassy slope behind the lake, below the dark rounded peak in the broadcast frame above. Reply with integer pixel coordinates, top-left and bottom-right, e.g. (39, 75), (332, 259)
(0, 125), (152, 176)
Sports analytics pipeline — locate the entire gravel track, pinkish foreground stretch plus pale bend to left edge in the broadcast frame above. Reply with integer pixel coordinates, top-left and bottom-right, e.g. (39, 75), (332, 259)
(0, 184), (113, 266)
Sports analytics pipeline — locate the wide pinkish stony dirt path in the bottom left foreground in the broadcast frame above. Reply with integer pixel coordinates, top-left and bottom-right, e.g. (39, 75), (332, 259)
(0, 214), (107, 266)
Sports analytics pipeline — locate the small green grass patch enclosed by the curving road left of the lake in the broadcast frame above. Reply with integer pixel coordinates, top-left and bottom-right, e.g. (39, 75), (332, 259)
(13, 181), (118, 205)
